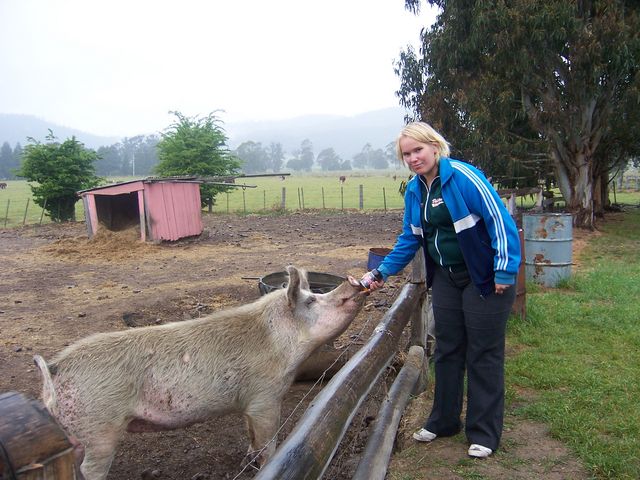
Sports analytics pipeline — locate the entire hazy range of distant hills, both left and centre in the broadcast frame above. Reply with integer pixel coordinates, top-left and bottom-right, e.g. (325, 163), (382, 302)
(0, 107), (405, 160)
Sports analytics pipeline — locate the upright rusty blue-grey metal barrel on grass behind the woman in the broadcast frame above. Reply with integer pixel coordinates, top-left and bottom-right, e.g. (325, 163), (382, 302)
(522, 213), (573, 287)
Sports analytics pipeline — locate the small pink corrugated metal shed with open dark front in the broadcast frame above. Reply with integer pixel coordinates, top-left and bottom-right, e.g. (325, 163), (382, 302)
(78, 179), (202, 241)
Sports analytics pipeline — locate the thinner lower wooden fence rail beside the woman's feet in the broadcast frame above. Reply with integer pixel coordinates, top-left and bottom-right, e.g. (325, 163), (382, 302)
(352, 345), (425, 480)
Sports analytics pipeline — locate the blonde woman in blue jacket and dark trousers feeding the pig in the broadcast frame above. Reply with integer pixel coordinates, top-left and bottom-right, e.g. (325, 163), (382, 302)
(363, 122), (520, 458)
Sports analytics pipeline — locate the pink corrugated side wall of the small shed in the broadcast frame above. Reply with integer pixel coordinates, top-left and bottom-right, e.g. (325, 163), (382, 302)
(144, 182), (202, 241)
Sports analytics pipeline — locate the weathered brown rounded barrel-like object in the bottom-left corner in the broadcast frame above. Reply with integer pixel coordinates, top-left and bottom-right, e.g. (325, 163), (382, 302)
(0, 392), (76, 480)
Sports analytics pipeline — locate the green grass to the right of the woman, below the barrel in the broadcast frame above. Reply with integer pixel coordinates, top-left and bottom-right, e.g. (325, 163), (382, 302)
(507, 204), (640, 480)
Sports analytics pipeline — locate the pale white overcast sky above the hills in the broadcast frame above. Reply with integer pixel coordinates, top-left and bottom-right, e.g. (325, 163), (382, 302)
(0, 0), (435, 136)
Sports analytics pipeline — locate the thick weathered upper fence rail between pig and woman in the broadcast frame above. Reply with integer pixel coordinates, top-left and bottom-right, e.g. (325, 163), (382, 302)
(254, 283), (423, 480)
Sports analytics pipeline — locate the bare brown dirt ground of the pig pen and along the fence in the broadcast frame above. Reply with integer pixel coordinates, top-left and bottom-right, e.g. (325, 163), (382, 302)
(0, 211), (588, 480)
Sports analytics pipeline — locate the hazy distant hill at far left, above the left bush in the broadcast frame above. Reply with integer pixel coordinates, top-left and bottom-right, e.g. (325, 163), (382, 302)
(0, 113), (120, 149)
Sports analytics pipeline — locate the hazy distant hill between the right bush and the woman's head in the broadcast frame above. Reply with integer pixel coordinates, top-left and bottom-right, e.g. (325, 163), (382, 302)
(225, 107), (405, 160)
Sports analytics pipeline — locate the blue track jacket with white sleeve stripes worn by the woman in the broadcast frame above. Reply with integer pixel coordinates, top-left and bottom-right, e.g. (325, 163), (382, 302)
(378, 158), (520, 295)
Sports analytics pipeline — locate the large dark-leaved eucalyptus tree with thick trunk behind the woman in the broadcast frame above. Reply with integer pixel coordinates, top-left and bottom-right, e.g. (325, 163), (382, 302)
(396, 0), (640, 228)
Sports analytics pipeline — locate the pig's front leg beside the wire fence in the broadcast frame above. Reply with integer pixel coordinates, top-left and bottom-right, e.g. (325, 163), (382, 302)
(242, 400), (280, 467)
